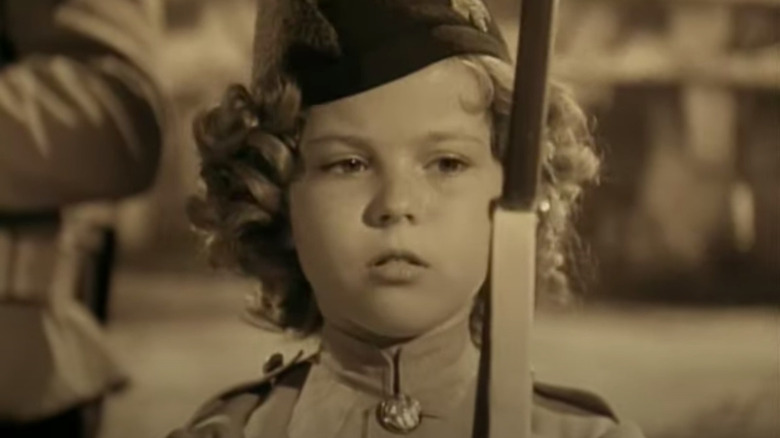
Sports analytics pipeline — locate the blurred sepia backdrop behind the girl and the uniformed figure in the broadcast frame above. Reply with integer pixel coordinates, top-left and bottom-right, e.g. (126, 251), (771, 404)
(62, 0), (780, 438)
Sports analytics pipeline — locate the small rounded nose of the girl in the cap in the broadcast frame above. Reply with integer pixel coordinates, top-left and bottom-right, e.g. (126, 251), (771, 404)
(367, 171), (424, 227)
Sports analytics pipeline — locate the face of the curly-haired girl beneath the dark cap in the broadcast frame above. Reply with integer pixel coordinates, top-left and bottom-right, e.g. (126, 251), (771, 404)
(289, 60), (502, 342)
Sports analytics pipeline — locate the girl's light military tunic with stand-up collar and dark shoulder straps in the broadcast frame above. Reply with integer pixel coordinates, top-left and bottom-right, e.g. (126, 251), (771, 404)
(171, 316), (641, 438)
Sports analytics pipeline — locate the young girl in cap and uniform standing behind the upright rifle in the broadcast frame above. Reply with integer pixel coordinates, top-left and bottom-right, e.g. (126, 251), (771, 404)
(171, 0), (640, 438)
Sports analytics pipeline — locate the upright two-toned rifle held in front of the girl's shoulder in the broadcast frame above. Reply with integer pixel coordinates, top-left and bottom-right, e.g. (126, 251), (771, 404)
(476, 0), (556, 438)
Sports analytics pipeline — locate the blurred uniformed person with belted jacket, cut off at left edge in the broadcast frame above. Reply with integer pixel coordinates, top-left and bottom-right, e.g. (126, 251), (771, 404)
(0, 0), (162, 438)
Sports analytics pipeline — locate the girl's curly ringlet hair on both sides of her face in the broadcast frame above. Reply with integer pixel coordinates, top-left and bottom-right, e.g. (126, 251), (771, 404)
(188, 55), (599, 341)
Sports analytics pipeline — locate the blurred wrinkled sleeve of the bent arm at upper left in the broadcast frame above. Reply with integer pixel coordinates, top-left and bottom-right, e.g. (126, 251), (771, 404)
(0, 0), (165, 212)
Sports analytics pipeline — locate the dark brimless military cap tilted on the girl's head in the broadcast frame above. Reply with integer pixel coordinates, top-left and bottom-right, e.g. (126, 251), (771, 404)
(252, 0), (510, 105)
